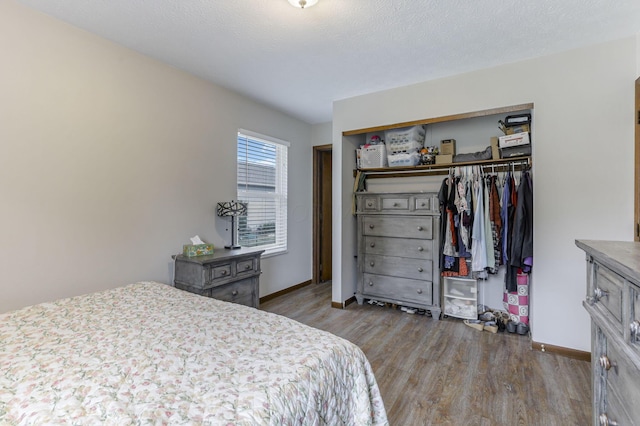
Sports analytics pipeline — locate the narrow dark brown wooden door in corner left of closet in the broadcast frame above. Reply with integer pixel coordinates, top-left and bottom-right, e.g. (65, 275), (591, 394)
(313, 145), (332, 283)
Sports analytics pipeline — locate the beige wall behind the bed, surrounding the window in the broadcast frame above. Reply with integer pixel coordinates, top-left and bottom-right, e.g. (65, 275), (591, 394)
(0, 0), (312, 312)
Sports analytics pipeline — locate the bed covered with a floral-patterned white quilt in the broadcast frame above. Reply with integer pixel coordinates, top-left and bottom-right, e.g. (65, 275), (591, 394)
(0, 282), (388, 425)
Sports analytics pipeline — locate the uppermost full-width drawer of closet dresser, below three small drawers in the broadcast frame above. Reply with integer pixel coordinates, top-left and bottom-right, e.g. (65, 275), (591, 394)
(362, 216), (433, 240)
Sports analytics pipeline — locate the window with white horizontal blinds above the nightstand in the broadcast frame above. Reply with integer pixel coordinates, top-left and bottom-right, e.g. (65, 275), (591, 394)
(237, 129), (289, 254)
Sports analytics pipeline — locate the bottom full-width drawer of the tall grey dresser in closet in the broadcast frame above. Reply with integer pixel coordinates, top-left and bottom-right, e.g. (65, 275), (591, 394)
(363, 274), (433, 305)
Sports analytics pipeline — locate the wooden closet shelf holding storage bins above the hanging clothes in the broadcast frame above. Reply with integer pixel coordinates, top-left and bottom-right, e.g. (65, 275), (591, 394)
(353, 156), (531, 178)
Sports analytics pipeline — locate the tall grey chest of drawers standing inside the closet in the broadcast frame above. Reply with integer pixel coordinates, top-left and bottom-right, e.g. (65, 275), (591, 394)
(356, 192), (442, 319)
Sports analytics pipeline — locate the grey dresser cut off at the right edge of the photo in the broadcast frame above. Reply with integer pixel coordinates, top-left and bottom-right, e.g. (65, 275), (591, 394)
(576, 240), (640, 425)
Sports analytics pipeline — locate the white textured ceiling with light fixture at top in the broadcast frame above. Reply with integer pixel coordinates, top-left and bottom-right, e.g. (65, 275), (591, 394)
(18, 0), (640, 123)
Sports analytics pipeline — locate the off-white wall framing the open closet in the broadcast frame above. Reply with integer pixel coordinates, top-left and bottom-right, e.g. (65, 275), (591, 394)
(333, 37), (638, 351)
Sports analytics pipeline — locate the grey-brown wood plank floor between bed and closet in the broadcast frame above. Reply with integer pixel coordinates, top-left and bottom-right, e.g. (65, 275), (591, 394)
(260, 283), (591, 426)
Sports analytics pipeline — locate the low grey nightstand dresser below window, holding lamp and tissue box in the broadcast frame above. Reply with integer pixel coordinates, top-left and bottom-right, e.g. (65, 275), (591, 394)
(174, 248), (264, 308)
